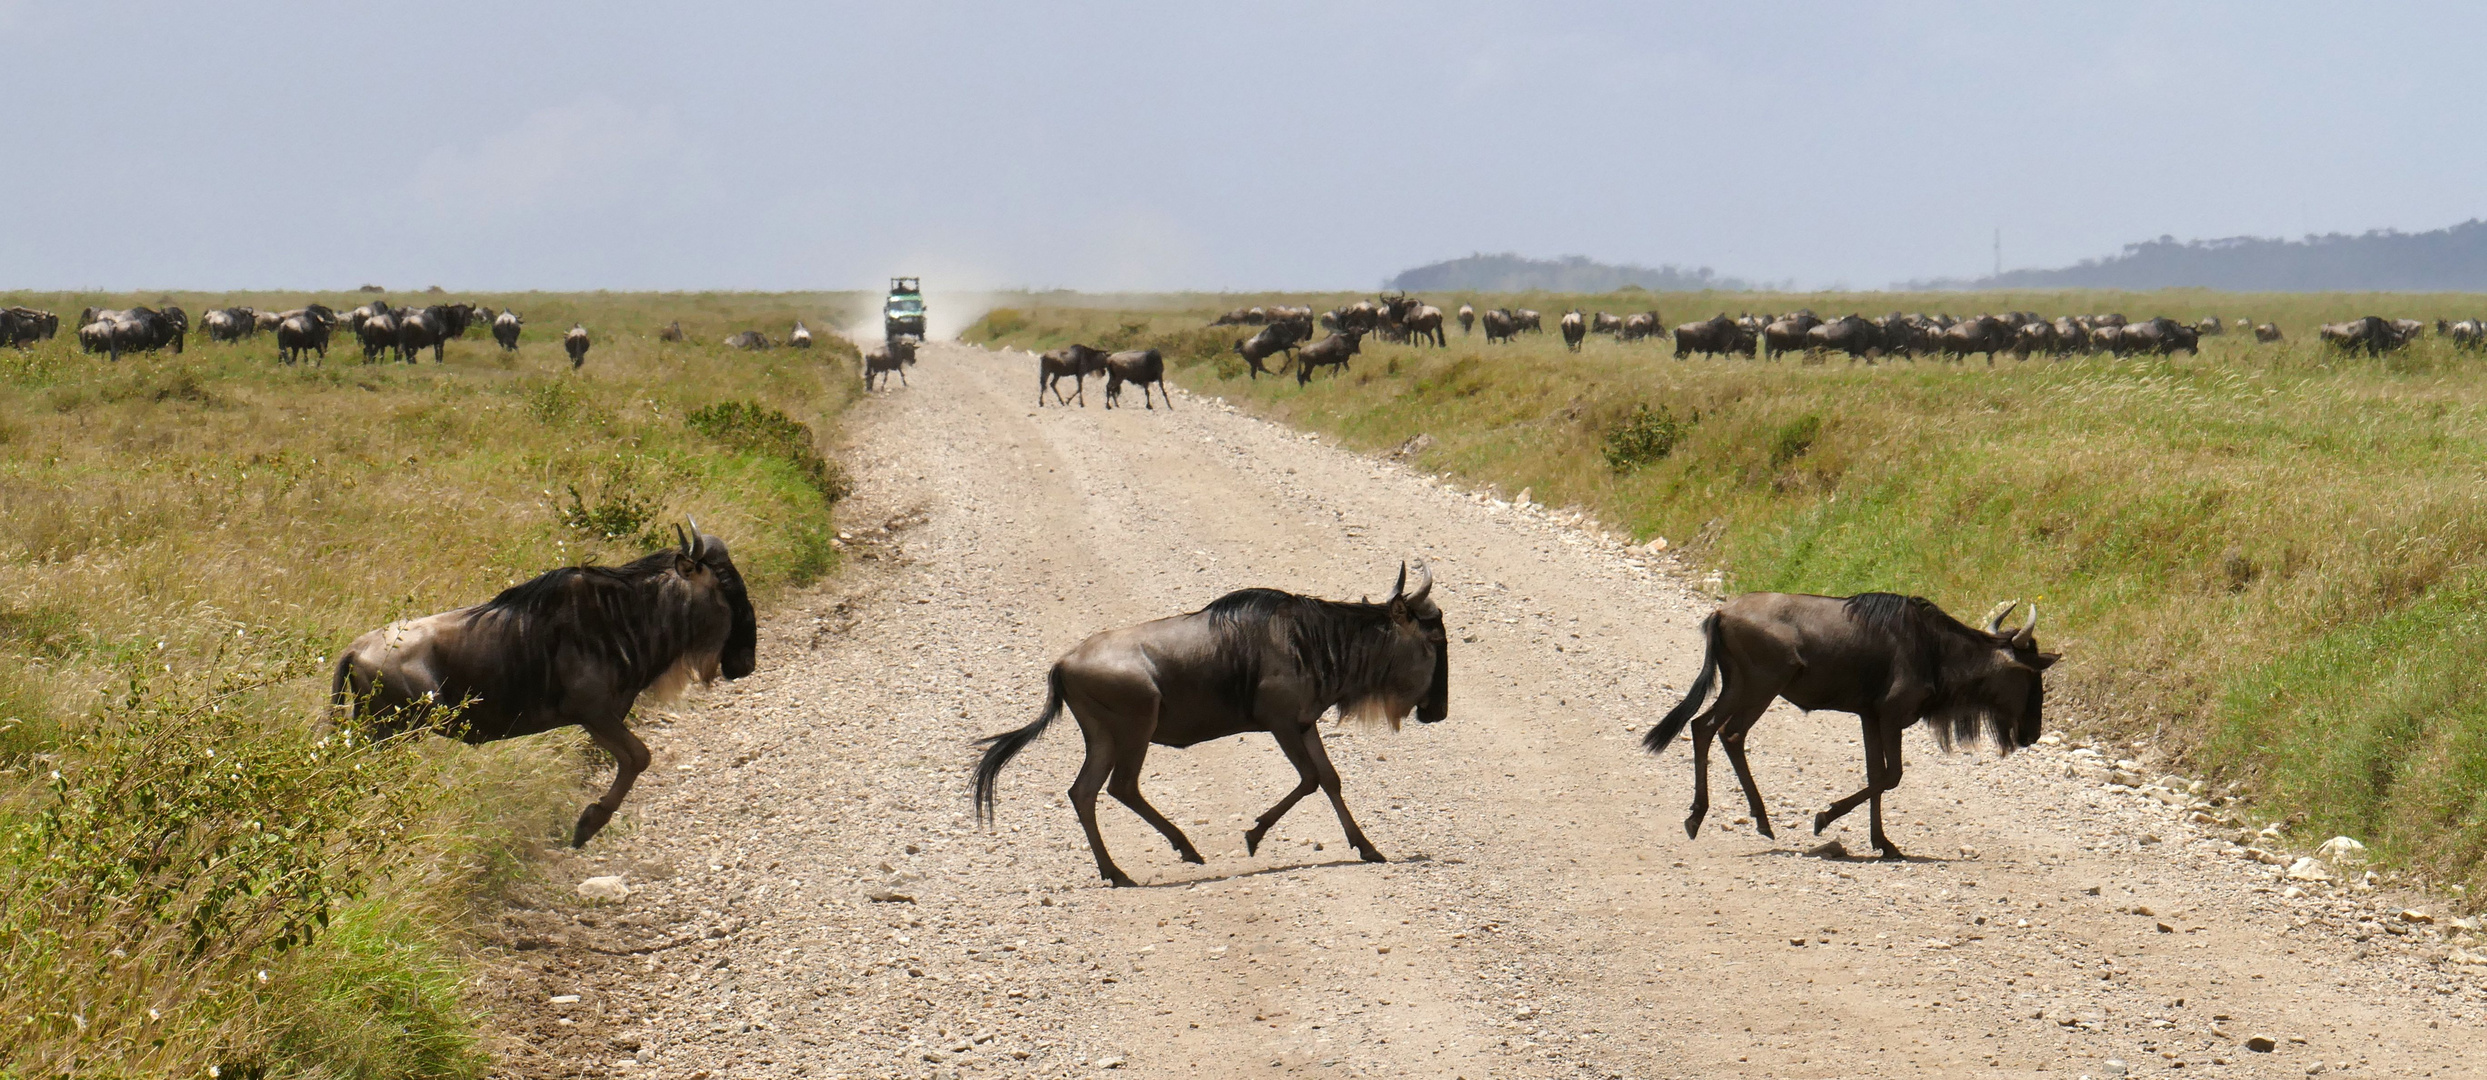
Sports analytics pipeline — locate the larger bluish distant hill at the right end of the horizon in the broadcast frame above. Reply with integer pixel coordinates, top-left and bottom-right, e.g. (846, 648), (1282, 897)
(1903, 219), (2487, 294)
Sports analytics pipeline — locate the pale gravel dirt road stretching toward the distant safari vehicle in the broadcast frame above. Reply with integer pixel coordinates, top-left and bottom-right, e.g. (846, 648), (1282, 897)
(492, 346), (2487, 1080)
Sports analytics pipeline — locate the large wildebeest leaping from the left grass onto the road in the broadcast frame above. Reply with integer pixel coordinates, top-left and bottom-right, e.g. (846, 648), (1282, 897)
(331, 523), (759, 846)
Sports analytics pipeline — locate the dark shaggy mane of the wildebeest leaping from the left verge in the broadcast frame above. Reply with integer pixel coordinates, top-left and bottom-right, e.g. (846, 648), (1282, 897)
(468, 550), (711, 714)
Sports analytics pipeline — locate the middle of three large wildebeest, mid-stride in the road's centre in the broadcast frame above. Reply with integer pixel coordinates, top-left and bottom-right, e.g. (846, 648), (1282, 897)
(975, 562), (1450, 886)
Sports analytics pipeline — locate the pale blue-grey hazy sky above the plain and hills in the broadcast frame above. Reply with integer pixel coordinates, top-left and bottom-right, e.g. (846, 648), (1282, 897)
(0, 0), (2487, 291)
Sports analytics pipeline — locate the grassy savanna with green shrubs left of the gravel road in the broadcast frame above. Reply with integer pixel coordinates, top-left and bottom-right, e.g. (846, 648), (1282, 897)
(0, 294), (858, 1078)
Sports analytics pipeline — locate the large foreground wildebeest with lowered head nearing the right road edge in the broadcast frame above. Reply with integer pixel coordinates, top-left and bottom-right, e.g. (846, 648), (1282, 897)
(1641, 592), (2059, 859)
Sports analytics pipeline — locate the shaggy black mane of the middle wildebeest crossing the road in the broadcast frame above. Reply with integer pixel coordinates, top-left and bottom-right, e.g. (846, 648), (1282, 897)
(1201, 590), (1398, 722)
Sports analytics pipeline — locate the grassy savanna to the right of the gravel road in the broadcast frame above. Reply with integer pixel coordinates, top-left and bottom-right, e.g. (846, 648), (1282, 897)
(967, 291), (2487, 900)
